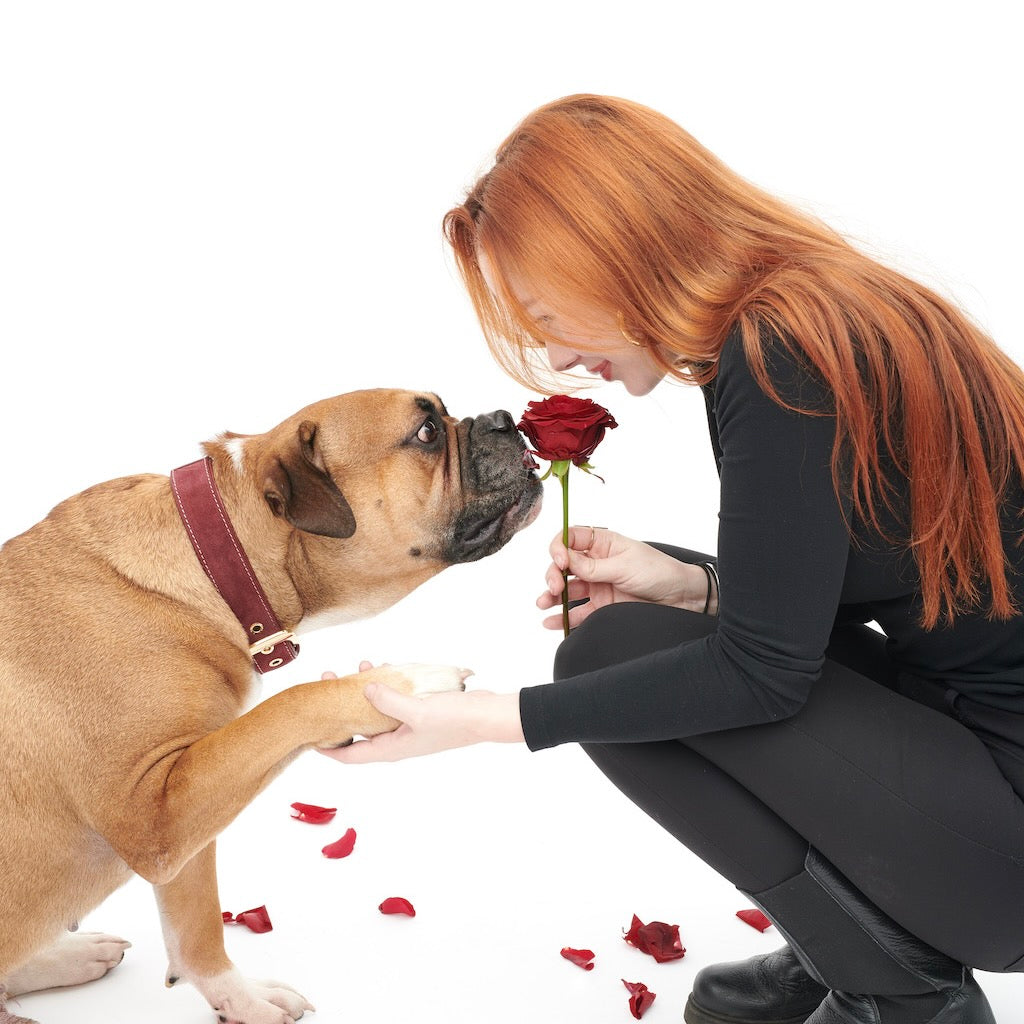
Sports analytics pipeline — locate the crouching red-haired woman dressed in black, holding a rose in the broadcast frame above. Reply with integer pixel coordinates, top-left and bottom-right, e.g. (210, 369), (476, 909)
(335, 96), (1024, 1024)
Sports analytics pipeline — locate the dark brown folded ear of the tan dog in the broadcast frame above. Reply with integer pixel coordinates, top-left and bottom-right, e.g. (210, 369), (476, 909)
(263, 421), (355, 538)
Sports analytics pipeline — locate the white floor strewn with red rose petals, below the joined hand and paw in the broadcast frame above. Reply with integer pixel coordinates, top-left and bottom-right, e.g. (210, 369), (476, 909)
(13, 749), (1024, 1024)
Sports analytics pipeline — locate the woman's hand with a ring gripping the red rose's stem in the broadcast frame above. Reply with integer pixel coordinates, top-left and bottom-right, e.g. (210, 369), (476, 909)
(537, 526), (708, 630)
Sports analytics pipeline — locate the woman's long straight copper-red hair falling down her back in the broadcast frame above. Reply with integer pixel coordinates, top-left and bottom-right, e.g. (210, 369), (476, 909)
(444, 95), (1024, 628)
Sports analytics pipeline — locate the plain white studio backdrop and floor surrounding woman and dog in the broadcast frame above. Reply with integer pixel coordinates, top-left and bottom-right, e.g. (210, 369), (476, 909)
(0, 0), (1024, 1024)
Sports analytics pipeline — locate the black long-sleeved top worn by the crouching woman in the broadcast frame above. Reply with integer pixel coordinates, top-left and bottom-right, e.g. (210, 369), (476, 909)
(520, 328), (1024, 750)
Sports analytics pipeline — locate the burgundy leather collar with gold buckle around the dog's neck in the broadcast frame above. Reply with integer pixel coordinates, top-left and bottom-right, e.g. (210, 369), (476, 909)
(171, 457), (299, 673)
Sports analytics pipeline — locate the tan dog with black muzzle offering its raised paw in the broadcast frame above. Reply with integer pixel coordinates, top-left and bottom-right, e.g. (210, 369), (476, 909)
(0, 390), (541, 1024)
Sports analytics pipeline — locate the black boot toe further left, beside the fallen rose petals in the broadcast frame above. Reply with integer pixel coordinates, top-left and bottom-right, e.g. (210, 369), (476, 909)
(683, 946), (828, 1024)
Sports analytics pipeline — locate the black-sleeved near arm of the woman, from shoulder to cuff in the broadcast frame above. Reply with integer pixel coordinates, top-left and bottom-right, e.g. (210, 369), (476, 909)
(520, 332), (850, 750)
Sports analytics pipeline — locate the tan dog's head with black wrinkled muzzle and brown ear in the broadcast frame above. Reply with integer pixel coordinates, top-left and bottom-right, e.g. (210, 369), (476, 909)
(261, 390), (542, 573)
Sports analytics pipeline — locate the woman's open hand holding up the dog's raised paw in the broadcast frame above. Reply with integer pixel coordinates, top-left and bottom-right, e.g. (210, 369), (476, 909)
(319, 662), (523, 765)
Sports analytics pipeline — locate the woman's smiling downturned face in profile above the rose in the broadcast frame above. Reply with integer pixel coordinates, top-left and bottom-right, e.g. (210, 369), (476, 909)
(478, 253), (665, 395)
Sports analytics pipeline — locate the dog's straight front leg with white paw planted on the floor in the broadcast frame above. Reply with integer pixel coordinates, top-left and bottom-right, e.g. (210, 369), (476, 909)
(154, 843), (313, 1024)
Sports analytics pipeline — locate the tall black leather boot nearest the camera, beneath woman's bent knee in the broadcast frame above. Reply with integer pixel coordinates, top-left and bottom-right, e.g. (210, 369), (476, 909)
(748, 849), (995, 1024)
